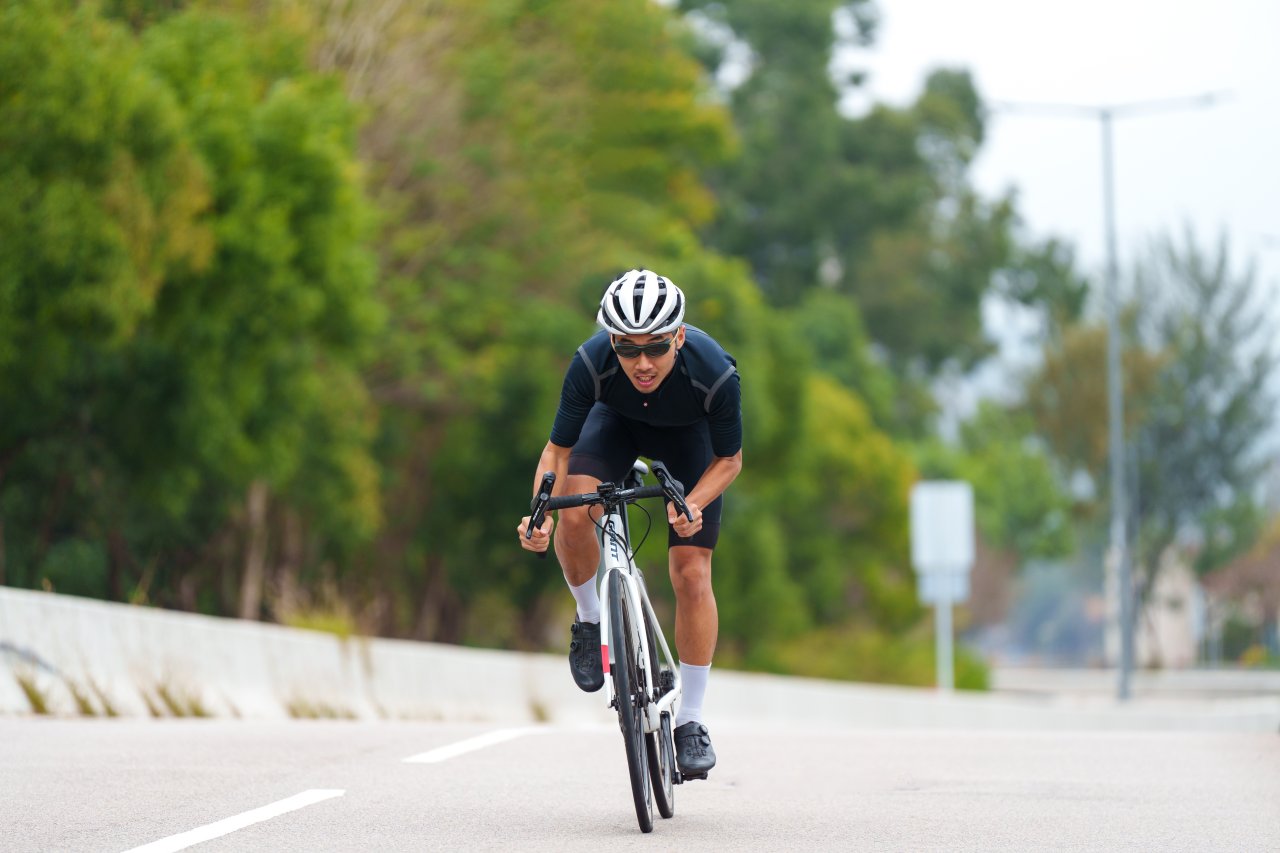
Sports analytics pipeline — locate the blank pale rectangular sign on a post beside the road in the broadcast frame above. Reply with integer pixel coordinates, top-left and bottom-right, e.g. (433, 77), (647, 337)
(911, 480), (973, 692)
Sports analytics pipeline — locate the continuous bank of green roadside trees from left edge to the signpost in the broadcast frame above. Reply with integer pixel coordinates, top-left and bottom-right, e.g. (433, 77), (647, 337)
(0, 0), (1061, 678)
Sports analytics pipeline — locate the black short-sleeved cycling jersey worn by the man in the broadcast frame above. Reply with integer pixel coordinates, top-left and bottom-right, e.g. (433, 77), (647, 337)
(550, 324), (742, 456)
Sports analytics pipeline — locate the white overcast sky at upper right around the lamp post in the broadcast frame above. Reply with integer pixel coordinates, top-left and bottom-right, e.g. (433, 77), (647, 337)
(858, 0), (1280, 363)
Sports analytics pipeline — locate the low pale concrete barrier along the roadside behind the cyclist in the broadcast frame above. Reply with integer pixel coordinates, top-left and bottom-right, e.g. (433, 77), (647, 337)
(0, 588), (1280, 733)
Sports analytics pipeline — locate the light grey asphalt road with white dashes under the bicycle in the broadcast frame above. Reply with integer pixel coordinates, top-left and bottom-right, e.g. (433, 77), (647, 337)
(0, 719), (1280, 853)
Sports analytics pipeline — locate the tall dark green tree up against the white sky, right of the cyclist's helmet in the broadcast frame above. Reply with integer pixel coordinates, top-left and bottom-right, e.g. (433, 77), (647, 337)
(680, 0), (1015, 379)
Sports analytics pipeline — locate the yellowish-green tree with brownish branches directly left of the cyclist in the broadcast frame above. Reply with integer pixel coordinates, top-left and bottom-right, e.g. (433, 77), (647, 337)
(302, 0), (728, 643)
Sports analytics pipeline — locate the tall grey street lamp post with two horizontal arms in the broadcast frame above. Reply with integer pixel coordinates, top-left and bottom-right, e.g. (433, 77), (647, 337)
(992, 93), (1221, 701)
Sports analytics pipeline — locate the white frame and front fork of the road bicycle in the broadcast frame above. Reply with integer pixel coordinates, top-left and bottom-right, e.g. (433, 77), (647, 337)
(595, 505), (681, 734)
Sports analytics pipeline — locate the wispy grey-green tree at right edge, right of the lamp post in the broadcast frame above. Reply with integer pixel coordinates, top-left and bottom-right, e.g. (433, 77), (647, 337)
(1130, 232), (1280, 599)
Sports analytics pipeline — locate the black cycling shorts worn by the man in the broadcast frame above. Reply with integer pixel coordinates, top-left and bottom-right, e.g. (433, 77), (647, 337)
(568, 402), (724, 548)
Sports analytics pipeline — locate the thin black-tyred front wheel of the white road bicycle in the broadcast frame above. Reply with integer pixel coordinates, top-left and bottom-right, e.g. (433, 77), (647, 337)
(609, 573), (653, 833)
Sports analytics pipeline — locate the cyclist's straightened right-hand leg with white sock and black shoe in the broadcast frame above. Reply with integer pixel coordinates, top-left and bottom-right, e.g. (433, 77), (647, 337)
(668, 546), (719, 776)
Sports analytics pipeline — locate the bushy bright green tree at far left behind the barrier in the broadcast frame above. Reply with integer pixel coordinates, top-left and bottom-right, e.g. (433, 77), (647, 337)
(0, 3), (379, 616)
